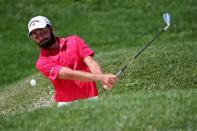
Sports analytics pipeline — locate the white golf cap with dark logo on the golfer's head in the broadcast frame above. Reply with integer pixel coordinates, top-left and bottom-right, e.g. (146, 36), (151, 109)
(28, 16), (52, 36)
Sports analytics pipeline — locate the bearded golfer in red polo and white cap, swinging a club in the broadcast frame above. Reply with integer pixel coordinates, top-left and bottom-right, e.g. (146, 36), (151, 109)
(28, 16), (117, 106)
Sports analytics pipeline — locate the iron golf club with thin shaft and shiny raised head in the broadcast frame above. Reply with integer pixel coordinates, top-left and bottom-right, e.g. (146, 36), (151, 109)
(100, 13), (171, 93)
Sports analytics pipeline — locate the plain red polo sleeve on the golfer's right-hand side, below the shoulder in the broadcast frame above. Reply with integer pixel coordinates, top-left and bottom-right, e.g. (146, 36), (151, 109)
(75, 36), (95, 59)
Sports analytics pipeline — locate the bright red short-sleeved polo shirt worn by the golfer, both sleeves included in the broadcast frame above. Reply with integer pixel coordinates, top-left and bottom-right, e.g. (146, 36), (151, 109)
(36, 36), (98, 102)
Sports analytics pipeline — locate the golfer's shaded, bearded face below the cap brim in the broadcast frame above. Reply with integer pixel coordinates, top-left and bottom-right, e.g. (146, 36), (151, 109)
(31, 27), (55, 49)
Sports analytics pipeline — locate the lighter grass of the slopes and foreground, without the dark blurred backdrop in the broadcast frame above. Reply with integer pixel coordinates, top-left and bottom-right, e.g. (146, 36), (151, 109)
(0, 42), (197, 131)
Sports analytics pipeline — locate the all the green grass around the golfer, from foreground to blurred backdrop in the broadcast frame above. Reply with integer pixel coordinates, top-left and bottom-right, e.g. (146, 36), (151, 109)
(0, 0), (197, 131)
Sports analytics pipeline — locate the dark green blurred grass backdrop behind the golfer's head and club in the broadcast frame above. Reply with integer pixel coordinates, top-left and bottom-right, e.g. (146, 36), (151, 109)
(0, 0), (197, 87)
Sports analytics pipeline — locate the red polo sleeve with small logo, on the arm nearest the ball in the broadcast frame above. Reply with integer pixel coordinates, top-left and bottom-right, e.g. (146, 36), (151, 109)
(36, 59), (62, 81)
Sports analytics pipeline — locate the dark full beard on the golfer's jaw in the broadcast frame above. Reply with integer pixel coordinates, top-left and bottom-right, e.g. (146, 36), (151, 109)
(37, 32), (56, 49)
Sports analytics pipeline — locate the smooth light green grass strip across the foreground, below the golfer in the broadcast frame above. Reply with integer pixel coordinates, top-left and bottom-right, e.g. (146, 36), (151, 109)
(0, 89), (197, 131)
